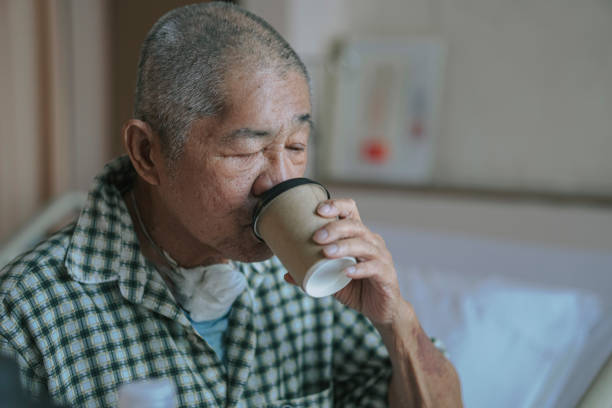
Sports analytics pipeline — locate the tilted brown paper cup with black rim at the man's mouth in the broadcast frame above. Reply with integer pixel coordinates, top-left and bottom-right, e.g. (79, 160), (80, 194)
(253, 178), (356, 297)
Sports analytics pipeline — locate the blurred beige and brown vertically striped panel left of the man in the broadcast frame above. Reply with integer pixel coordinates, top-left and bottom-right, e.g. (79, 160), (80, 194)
(0, 0), (110, 242)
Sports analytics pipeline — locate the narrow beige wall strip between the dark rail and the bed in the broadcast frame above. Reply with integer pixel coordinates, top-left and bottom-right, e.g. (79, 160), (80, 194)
(330, 185), (612, 252)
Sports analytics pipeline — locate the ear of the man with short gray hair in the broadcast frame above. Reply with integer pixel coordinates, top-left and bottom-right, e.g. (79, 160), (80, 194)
(123, 119), (164, 186)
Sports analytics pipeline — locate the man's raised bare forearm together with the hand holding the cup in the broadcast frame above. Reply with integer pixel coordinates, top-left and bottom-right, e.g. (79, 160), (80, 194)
(285, 199), (462, 407)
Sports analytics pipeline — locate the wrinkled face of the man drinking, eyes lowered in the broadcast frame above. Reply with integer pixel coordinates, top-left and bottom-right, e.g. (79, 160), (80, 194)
(160, 71), (311, 261)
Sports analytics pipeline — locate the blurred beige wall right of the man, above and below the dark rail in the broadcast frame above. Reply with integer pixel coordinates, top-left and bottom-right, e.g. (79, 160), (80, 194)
(242, 0), (612, 251)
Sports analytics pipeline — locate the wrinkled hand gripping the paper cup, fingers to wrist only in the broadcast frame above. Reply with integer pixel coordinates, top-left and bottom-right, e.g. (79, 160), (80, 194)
(285, 199), (402, 325)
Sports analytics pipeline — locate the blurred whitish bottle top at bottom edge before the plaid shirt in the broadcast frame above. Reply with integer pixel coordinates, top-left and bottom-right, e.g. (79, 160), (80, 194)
(117, 378), (177, 408)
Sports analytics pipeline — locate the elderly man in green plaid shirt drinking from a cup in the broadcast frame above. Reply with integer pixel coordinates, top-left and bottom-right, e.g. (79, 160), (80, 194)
(0, 3), (461, 407)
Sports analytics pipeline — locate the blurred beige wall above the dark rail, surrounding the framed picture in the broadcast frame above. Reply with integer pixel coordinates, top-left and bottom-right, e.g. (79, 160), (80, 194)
(243, 0), (612, 196)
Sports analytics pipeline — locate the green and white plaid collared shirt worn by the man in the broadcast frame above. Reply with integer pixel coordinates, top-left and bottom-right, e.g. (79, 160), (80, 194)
(0, 157), (391, 408)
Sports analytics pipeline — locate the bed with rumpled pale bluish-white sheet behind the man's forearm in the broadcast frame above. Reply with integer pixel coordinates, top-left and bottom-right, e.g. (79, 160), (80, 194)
(372, 225), (612, 408)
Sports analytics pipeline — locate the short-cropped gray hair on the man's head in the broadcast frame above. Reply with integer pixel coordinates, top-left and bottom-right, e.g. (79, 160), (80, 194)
(134, 2), (310, 164)
